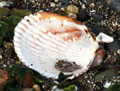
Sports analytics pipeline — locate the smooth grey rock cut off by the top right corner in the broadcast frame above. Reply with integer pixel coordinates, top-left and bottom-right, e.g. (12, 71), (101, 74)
(107, 0), (120, 12)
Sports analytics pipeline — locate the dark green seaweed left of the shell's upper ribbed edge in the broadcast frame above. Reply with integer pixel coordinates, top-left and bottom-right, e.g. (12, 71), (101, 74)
(0, 8), (31, 46)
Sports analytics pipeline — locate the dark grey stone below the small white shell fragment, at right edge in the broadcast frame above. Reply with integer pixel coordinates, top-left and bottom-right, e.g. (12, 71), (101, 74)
(106, 39), (120, 51)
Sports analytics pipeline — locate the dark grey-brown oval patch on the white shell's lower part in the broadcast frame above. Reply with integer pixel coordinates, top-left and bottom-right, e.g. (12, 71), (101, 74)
(55, 60), (81, 72)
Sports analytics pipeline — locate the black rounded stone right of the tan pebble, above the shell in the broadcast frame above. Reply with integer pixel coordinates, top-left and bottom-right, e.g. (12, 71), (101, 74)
(77, 9), (89, 21)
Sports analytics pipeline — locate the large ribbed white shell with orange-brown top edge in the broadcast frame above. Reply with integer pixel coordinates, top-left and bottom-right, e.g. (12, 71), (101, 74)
(14, 12), (99, 79)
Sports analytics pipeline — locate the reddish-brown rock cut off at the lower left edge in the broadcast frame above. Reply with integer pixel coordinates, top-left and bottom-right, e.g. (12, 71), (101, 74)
(0, 70), (9, 91)
